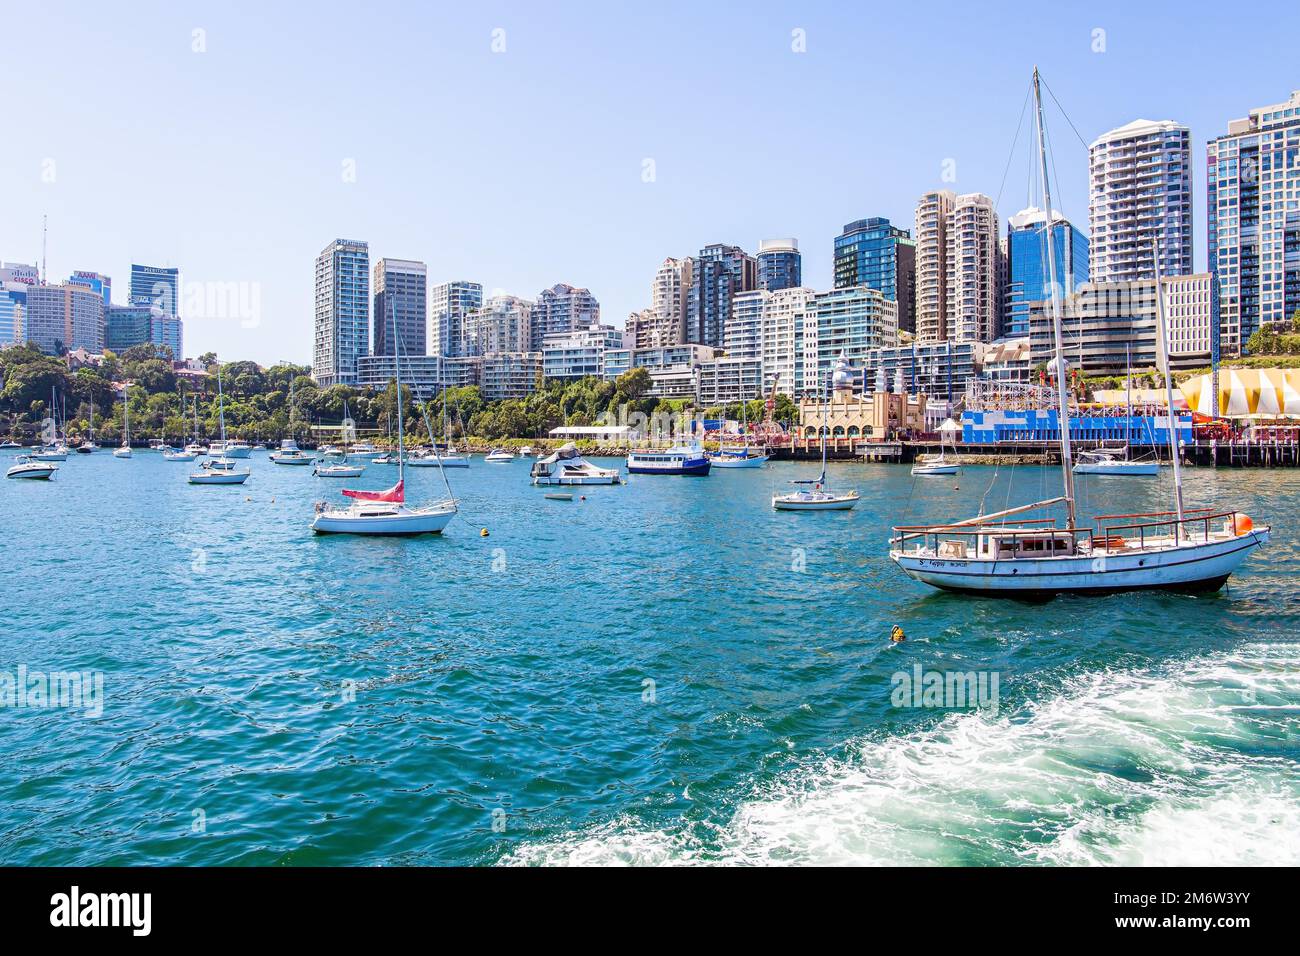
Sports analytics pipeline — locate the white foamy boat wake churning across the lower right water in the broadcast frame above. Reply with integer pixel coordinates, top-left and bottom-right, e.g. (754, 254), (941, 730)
(503, 644), (1300, 866)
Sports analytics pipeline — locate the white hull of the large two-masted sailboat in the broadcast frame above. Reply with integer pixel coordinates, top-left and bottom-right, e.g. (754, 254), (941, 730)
(889, 528), (1270, 600)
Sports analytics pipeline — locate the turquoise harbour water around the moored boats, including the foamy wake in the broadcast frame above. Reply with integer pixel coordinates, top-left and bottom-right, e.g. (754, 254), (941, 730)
(0, 451), (1300, 865)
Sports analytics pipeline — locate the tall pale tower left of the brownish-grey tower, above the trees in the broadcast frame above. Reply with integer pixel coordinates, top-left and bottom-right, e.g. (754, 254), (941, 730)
(314, 239), (371, 388)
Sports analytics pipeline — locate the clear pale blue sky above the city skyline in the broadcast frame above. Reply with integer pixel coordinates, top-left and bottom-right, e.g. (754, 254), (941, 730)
(0, 0), (1300, 363)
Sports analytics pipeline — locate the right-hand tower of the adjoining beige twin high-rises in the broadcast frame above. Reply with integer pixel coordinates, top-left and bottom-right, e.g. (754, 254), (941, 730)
(946, 193), (1002, 342)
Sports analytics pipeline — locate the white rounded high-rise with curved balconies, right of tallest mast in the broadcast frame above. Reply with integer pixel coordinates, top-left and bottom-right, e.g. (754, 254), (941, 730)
(1088, 120), (1192, 282)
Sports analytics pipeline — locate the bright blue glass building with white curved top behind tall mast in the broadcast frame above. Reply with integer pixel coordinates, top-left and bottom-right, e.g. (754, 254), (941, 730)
(1002, 206), (1089, 337)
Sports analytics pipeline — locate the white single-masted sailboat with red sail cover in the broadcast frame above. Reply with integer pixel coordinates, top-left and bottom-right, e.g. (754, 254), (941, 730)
(311, 295), (456, 535)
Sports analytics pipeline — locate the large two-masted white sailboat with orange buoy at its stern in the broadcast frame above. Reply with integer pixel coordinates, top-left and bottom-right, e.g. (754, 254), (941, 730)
(889, 69), (1271, 598)
